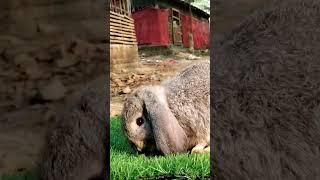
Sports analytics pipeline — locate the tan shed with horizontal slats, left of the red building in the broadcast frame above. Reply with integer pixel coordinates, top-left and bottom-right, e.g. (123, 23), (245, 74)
(110, 0), (139, 70)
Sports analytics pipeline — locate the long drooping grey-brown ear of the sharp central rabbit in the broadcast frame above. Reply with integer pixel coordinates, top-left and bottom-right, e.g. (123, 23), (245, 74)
(144, 87), (187, 155)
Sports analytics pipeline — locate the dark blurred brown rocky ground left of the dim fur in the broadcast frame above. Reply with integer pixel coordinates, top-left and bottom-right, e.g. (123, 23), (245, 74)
(0, 0), (107, 175)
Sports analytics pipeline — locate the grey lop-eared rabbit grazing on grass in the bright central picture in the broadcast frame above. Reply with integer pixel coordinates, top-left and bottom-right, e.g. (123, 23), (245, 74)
(121, 62), (210, 155)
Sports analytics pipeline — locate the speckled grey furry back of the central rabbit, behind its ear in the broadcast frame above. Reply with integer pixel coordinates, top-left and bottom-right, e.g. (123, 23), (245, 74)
(163, 62), (210, 143)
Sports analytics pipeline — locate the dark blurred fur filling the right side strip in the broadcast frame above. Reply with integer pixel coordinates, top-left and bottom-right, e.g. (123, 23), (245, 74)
(211, 0), (320, 179)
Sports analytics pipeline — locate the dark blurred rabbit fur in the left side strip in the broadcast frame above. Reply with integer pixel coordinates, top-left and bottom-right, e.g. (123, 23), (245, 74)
(40, 79), (107, 180)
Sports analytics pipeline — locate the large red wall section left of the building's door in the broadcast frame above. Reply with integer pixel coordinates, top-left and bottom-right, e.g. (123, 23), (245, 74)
(132, 8), (170, 45)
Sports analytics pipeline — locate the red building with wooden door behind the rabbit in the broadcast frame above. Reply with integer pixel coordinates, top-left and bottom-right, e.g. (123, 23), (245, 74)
(132, 0), (210, 49)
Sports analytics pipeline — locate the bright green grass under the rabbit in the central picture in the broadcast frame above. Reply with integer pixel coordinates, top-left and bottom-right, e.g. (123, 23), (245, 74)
(110, 117), (210, 180)
